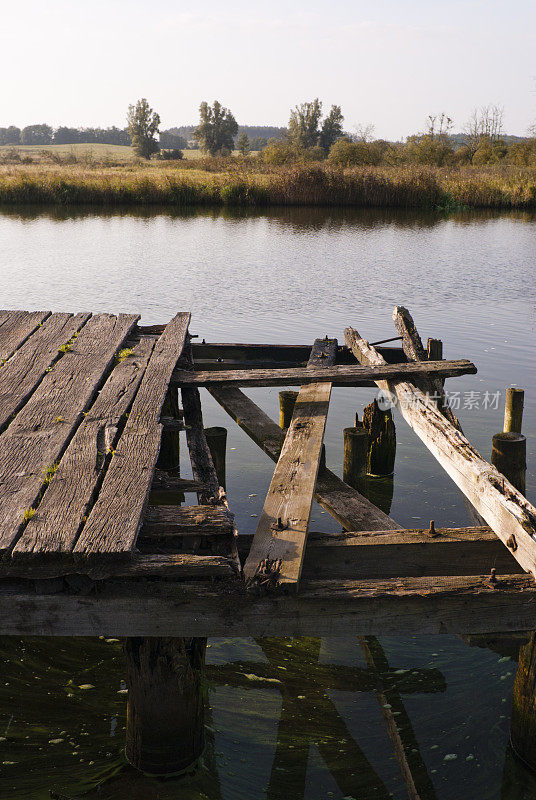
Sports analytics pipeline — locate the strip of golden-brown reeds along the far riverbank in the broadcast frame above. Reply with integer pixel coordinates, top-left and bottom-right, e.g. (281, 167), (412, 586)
(0, 159), (536, 210)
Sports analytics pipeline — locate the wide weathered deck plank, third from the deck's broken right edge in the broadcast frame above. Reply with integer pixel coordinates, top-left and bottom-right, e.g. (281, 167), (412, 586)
(0, 314), (138, 552)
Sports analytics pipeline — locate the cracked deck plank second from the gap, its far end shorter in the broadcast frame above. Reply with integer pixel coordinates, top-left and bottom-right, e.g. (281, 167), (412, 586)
(13, 338), (154, 558)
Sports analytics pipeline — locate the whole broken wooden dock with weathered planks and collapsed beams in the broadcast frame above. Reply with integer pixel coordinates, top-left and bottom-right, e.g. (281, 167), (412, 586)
(0, 309), (536, 637)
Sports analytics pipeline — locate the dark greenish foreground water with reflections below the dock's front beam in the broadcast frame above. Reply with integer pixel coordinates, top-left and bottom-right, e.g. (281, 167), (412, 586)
(0, 635), (536, 800)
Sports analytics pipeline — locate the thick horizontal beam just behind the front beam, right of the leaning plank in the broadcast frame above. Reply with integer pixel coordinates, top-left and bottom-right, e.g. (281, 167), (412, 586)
(238, 526), (523, 580)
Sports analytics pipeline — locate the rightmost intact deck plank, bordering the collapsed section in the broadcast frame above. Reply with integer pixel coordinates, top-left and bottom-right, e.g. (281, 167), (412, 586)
(73, 313), (190, 558)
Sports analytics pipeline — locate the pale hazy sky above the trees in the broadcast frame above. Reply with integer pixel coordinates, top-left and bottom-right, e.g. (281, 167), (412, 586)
(0, 0), (536, 139)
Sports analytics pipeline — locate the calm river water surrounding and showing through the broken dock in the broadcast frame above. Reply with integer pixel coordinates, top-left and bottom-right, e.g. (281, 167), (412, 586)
(0, 209), (536, 800)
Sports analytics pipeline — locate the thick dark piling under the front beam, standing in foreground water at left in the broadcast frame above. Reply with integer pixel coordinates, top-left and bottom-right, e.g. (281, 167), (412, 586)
(125, 637), (206, 775)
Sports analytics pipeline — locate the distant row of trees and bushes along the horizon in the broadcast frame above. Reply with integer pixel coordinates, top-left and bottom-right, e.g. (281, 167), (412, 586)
(0, 98), (536, 167)
